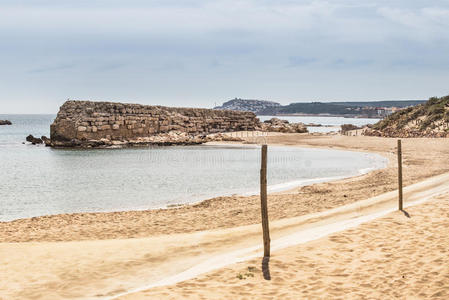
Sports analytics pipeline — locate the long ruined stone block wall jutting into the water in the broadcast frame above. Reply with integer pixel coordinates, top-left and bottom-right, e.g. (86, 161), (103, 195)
(50, 101), (260, 147)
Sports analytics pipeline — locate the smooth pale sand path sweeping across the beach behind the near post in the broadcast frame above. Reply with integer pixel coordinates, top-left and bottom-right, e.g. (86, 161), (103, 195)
(0, 173), (449, 299)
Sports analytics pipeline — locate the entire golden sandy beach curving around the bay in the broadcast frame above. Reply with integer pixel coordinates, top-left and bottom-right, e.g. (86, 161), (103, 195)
(0, 134), (449, 299)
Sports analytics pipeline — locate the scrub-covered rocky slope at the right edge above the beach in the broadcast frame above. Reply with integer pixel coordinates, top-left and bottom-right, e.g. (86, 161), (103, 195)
(365, 96), (449, 137)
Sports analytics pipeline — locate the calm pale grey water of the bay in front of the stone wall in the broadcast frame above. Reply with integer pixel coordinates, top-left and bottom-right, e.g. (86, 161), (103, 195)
(0, 115), (386, 221)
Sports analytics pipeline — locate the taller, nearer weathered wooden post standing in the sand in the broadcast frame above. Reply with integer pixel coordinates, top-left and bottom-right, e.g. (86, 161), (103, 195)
(260, 145), (270, 257)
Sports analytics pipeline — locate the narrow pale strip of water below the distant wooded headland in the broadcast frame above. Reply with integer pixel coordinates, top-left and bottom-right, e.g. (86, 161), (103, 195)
(259, 116), (381, 132)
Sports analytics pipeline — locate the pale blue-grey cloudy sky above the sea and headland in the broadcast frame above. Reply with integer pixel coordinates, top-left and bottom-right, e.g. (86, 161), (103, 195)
(0, 0), (449, 114)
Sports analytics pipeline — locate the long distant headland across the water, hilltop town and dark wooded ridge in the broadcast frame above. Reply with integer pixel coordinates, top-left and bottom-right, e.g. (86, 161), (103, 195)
(215, 98), (425, 118)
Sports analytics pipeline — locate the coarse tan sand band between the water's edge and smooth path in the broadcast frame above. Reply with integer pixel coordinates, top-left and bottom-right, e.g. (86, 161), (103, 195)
(0, 134), (449, 243)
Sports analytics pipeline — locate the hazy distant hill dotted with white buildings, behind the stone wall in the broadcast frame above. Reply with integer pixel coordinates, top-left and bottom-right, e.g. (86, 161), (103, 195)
(214, 98), (281, 115)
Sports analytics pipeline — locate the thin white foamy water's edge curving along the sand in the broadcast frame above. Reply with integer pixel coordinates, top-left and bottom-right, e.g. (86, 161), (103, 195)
(0, 142), (391, 224)
